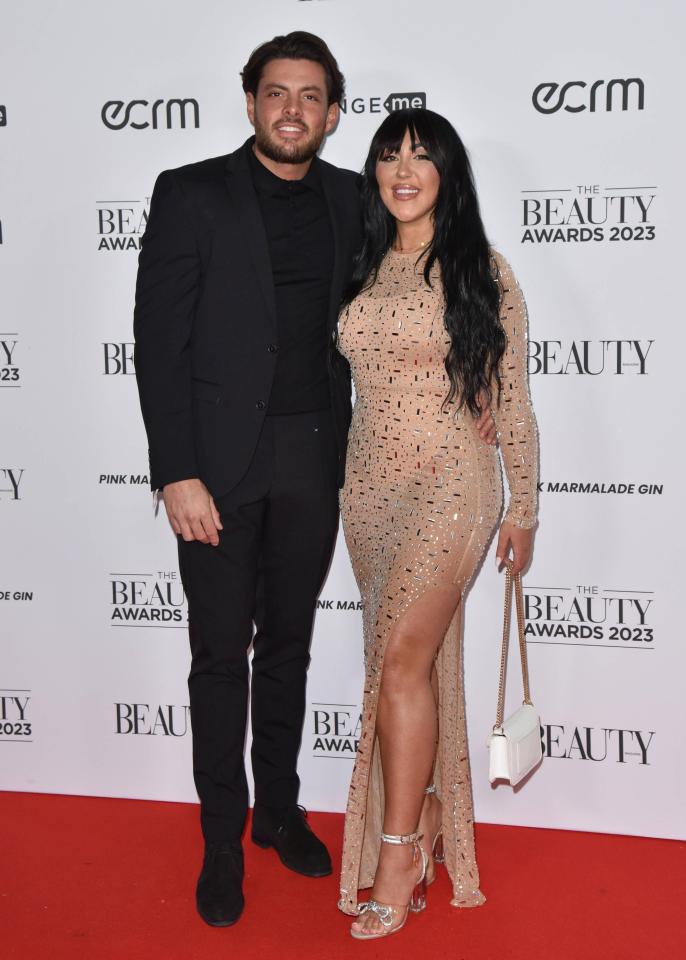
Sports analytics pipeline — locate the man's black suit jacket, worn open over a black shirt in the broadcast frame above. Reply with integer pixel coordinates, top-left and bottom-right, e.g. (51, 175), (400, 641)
(134, 138), (361, 496)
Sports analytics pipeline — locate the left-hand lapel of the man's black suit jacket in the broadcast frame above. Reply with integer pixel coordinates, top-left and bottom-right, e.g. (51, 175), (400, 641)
(226, 138), (276, 334)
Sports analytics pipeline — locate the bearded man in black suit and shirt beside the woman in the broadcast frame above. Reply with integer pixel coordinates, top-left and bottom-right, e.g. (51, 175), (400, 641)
(134, 32), (494, 926)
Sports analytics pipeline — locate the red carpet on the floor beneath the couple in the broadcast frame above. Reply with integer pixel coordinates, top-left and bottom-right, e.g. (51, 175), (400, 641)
(0, 793), (686, 960)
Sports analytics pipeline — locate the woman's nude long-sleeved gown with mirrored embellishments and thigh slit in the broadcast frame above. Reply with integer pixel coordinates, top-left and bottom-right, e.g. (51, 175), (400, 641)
(339, 251), (538, 914)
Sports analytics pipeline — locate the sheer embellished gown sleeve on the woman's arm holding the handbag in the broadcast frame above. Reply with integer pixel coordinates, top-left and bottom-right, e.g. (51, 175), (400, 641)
(492, 253), (539, 527)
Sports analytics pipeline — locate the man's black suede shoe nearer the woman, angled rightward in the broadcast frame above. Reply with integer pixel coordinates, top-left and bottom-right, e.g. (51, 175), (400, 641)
(252, 806), (331, 877)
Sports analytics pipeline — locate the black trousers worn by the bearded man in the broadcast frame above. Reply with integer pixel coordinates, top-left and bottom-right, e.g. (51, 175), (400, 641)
(179, 410), (338, 841)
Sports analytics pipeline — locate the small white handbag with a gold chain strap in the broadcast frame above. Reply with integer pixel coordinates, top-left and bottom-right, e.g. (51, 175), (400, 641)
(486, 560), (543, 787)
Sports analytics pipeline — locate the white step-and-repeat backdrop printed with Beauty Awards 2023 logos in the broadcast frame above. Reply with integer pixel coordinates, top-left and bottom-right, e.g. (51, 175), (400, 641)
(0, 0), (686, 838)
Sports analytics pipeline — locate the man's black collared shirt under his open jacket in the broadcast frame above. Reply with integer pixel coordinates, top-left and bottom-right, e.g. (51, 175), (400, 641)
(250, 151), (334, 415)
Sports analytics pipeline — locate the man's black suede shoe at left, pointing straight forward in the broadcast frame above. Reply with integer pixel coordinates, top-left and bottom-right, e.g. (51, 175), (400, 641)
(195, 841), (244, 927)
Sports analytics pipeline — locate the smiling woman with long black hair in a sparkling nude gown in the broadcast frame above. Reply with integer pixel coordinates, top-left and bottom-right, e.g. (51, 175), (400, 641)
(339, 110), (538, 939)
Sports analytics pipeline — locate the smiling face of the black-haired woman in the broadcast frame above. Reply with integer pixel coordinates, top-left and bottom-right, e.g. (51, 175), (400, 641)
(376, 131), (440, 232)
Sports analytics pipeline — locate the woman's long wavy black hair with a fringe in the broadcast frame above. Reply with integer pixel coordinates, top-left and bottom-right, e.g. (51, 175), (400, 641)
(344, 109), (506, 416)
